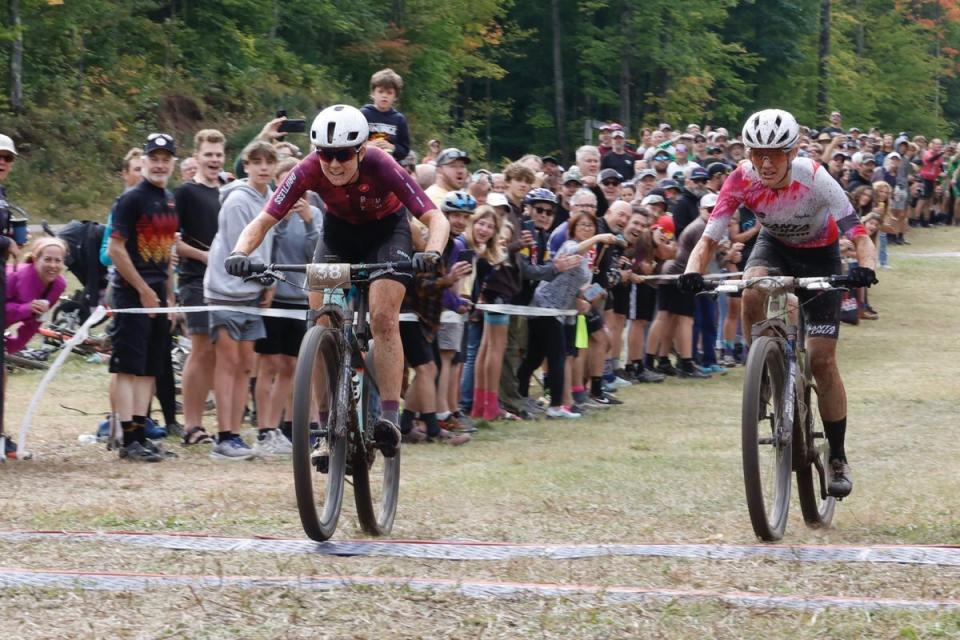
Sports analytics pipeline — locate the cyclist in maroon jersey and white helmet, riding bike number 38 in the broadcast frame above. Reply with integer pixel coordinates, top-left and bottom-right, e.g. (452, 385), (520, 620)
(225, 105), (450, 457)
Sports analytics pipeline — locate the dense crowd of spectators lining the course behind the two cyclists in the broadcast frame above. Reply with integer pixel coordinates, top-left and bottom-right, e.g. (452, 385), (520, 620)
(0, 69), (960, 462)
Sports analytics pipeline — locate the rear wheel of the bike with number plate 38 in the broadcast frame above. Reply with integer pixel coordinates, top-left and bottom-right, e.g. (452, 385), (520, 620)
(353, 354), (402, 536)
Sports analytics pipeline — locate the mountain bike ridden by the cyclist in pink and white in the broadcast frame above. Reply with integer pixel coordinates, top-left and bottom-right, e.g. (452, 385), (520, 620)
(708, 276), (847, 541)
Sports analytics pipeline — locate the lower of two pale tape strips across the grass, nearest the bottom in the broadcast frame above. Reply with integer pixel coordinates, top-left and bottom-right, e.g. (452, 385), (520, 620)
(0, 567), (960, 611)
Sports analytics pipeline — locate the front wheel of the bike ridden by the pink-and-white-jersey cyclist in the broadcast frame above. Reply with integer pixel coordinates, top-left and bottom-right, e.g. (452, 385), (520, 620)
(740, 336), (793, 541)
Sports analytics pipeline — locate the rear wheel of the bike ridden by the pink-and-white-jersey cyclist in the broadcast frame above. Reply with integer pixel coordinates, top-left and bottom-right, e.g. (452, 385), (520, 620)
(797, 385), (837, 528)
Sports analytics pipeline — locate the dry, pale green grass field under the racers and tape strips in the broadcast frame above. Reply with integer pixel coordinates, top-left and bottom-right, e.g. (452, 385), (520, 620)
(0, 228), (960, 638)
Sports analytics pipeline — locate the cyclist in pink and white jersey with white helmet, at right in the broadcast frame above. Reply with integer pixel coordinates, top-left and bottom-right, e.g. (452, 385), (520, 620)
(679, 109), (877, 498)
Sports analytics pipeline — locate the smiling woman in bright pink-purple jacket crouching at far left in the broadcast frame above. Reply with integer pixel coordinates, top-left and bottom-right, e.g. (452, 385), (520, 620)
(6, 238), (67, 353)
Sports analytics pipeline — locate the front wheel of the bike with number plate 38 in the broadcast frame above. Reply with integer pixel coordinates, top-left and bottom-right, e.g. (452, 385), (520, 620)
(293, 327), (350, 541)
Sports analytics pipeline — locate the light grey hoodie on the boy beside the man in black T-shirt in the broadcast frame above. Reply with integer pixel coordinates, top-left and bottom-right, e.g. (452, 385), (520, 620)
(203, 179), (273, 302)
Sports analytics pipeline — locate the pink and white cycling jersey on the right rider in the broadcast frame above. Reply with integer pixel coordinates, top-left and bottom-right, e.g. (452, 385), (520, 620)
(704, 158), (867, 247)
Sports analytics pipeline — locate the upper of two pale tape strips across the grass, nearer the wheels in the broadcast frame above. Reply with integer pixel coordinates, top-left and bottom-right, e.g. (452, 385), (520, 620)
(0, 531), (960, 567)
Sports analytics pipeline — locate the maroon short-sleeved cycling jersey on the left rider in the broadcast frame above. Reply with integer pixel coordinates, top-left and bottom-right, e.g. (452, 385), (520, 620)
(267, 147), (436, 224)
